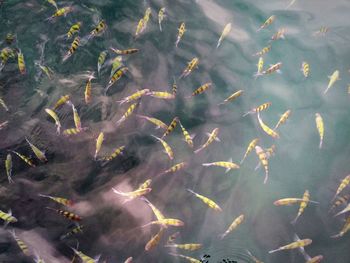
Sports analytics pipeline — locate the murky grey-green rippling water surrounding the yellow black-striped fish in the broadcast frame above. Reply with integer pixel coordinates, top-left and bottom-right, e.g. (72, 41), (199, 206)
(0, 0), (350, 263)
